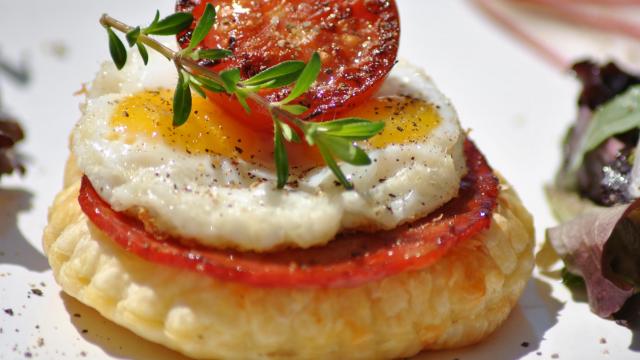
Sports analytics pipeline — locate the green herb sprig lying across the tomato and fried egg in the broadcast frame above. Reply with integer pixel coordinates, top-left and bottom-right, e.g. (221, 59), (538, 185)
(100, 4), (384, 189)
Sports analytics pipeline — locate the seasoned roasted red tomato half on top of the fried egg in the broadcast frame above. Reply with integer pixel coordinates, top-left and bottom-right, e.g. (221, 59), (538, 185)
(176, 0), (400, 129)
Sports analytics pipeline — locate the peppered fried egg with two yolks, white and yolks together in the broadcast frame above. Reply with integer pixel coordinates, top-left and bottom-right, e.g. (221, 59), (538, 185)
(71, 48), (466, 251)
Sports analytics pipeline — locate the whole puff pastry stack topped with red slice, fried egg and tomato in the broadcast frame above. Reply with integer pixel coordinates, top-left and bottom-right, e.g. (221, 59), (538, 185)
(44, 0), (534, 359)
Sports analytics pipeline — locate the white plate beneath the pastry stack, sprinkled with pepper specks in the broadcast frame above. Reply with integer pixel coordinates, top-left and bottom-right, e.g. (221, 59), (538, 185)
(0, 0), (640, 359)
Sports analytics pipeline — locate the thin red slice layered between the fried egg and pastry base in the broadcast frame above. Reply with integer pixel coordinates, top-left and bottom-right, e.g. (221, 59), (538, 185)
(79, 141), (498, 288)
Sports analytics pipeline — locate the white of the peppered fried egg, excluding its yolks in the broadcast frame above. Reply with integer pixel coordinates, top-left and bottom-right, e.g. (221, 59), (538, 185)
(71, 48), (466, 251)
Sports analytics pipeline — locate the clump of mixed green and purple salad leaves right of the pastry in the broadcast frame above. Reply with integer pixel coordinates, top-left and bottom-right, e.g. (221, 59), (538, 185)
(547, 61), (640, 327)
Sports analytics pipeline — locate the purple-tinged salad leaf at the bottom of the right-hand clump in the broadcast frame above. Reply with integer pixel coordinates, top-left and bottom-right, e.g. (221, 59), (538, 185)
(547, 200), (640, 318)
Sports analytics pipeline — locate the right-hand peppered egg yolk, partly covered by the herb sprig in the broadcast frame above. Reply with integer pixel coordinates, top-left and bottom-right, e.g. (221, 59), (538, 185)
(343, 96), (440, 149)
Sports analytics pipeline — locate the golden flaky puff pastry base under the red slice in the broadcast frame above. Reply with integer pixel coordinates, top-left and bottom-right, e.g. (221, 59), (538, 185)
(44, 161), (534, 359)
